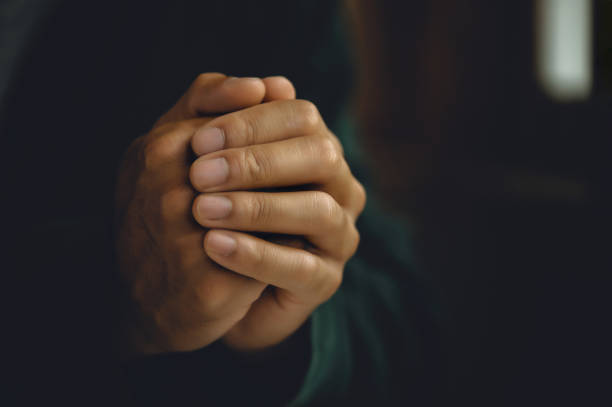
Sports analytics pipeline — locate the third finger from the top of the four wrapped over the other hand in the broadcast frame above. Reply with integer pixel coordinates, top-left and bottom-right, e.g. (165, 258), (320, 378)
(192, 191), (359, 261)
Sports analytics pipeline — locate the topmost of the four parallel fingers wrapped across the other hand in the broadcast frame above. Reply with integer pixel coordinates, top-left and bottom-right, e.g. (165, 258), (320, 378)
(191, 100), (330, 156)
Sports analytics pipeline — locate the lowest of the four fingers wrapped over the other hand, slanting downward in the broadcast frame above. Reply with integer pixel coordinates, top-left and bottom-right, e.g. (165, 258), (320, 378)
(204, 230), (342, 297)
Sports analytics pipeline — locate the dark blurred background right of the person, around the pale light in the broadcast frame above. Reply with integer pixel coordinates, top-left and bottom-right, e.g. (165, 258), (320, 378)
(357, 1), (612, 405)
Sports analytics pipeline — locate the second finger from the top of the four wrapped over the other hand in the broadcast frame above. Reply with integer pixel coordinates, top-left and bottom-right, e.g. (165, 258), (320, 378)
(189, 136), (350, 192)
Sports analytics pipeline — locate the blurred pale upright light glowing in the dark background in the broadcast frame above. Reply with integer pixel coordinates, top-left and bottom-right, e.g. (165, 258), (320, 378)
(535, 0), (593, 102)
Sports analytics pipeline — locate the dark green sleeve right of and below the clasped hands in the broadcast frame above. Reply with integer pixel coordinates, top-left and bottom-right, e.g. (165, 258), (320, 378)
(291, 114), (441, 406)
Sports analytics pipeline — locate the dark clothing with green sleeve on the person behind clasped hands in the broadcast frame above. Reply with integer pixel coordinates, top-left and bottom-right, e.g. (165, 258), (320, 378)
(0, 0), (439, 405)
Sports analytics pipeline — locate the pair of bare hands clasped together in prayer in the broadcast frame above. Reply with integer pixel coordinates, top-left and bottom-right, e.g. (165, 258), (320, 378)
(116, 74), (365, 356)
